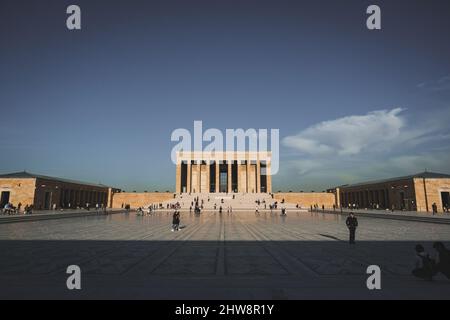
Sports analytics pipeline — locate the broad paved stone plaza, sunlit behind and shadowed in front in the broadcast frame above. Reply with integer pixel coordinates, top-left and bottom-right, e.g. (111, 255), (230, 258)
(0, 210), (450, 299)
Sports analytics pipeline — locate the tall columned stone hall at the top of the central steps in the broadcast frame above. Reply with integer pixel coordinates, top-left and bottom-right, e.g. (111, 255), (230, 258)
(176, 151), (272, 193)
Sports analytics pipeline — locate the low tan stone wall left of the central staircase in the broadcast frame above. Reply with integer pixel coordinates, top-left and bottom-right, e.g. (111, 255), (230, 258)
(112, 192), (173, 209)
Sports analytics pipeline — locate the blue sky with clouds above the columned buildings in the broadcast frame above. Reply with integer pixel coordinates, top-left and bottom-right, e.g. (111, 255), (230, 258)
(0, 0), (450, 191)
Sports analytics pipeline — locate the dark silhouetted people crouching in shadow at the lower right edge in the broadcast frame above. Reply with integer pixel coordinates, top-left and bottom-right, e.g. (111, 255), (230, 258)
(412, 242), (450, 281)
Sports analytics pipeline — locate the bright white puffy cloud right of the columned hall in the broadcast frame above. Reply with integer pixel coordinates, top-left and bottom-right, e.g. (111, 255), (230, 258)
(282, 108), (404, 156)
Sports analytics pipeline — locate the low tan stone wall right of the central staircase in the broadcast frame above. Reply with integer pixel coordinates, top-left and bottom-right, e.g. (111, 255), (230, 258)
(274, 192), (335, 208)
